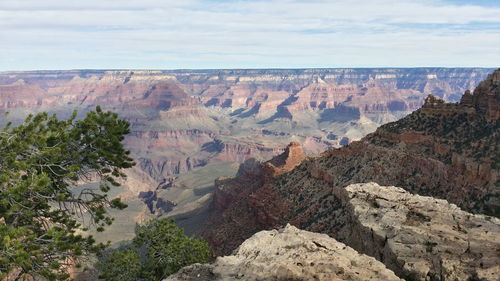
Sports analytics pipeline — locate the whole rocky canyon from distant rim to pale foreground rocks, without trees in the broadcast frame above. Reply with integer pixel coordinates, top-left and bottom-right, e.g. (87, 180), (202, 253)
(0, 68), (500, 281)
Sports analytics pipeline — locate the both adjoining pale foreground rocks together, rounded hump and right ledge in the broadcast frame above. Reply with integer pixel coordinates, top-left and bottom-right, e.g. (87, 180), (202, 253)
(173, 183), (500, 281)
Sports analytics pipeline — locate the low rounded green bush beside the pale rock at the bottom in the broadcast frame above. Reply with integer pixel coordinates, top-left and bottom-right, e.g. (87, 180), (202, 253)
(97, 219), (210, 281)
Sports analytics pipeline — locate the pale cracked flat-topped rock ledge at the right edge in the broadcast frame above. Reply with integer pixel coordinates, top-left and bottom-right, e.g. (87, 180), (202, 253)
(334, 183), (500, 280)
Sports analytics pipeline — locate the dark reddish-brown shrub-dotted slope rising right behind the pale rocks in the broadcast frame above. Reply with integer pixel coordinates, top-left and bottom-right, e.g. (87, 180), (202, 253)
(204, 70), (500, 255)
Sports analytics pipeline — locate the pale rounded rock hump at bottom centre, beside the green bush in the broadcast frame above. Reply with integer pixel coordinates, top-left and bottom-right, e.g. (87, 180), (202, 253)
(166, 225), (401, 281)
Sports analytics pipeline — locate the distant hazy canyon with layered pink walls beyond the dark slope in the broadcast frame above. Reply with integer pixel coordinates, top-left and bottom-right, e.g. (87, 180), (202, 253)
(0, 68), (492, 239)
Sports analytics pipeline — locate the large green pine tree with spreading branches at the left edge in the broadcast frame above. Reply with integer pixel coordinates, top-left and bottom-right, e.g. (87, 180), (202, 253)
(0, 107), (134, 280)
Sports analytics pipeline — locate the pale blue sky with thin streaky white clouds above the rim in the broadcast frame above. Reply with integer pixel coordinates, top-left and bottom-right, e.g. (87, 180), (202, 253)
(0, 0), (500, 71)
